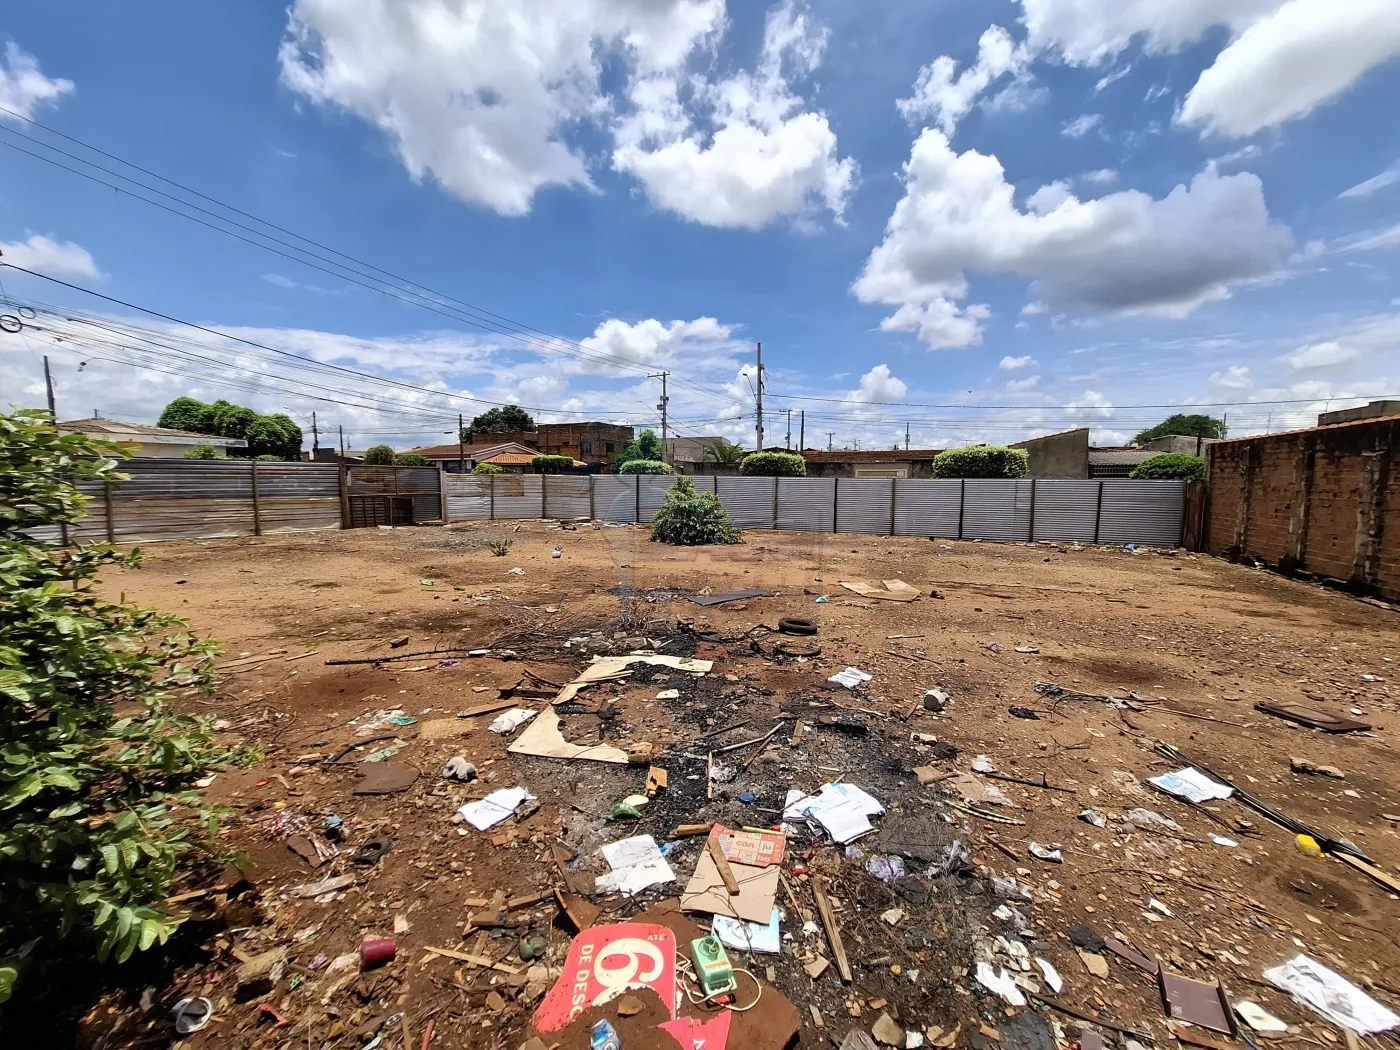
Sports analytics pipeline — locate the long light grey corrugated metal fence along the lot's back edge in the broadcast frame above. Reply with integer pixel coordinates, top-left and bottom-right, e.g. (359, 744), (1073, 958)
(444, 475), (1186, 547)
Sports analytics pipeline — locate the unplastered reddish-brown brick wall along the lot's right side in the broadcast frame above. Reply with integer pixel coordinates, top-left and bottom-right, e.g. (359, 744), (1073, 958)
(1205, 417), (1400, 601)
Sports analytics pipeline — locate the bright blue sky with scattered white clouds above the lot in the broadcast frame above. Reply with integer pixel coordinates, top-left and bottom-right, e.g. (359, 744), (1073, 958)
(0, 0), (1400, 448)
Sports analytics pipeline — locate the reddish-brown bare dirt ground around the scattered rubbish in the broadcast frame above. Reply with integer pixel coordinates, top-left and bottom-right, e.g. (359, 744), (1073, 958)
(60, 522), (1400, 1050)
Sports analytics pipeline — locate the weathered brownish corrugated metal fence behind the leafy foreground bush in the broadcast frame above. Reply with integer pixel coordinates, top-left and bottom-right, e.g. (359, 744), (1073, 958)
(36, 459), (340, 543)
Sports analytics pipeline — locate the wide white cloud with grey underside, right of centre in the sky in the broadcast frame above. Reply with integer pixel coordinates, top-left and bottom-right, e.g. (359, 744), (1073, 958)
(853, 129), (1292, 349)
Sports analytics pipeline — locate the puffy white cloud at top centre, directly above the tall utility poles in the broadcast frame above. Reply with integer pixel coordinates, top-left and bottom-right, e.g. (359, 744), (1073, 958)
(613, 0), (857, 230)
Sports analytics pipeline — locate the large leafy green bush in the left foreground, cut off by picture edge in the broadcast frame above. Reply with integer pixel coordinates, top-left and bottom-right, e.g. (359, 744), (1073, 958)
(0, 412), (237, 1001)
